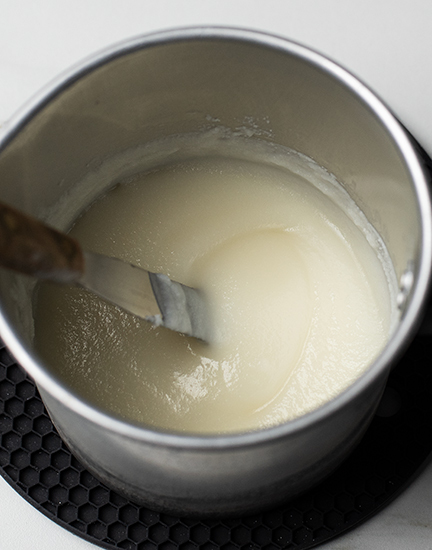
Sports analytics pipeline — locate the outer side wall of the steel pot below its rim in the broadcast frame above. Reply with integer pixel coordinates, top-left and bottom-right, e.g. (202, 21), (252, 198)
(41, 375), (387, 517)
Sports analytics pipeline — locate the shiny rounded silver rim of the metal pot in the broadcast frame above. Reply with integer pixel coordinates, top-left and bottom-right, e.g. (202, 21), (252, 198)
(0, 26), (432, 450)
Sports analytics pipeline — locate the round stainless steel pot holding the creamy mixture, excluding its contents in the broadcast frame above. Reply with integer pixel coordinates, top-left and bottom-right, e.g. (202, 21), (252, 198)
(0, 28), (432, 515)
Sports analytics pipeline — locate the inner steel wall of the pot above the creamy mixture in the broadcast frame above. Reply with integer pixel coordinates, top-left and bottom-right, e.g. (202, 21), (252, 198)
(0, 38), (420, 358)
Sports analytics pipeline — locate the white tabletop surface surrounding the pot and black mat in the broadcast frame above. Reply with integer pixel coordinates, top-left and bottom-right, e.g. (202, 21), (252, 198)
(0, 0), (432, 550)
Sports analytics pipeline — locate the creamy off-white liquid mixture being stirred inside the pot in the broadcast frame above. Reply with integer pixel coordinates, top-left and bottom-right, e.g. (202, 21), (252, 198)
(35, 153), (392, 433)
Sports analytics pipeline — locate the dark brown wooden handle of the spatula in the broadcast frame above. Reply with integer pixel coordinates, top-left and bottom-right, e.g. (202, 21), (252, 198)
(0, 203), (84, 283)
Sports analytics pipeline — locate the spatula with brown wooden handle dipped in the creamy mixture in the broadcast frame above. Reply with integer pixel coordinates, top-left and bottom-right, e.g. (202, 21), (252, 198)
(0, 203), (209, 341)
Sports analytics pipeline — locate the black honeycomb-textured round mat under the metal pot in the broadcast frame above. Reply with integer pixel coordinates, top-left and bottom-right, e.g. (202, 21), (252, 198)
(0, 336), (432, 550)
